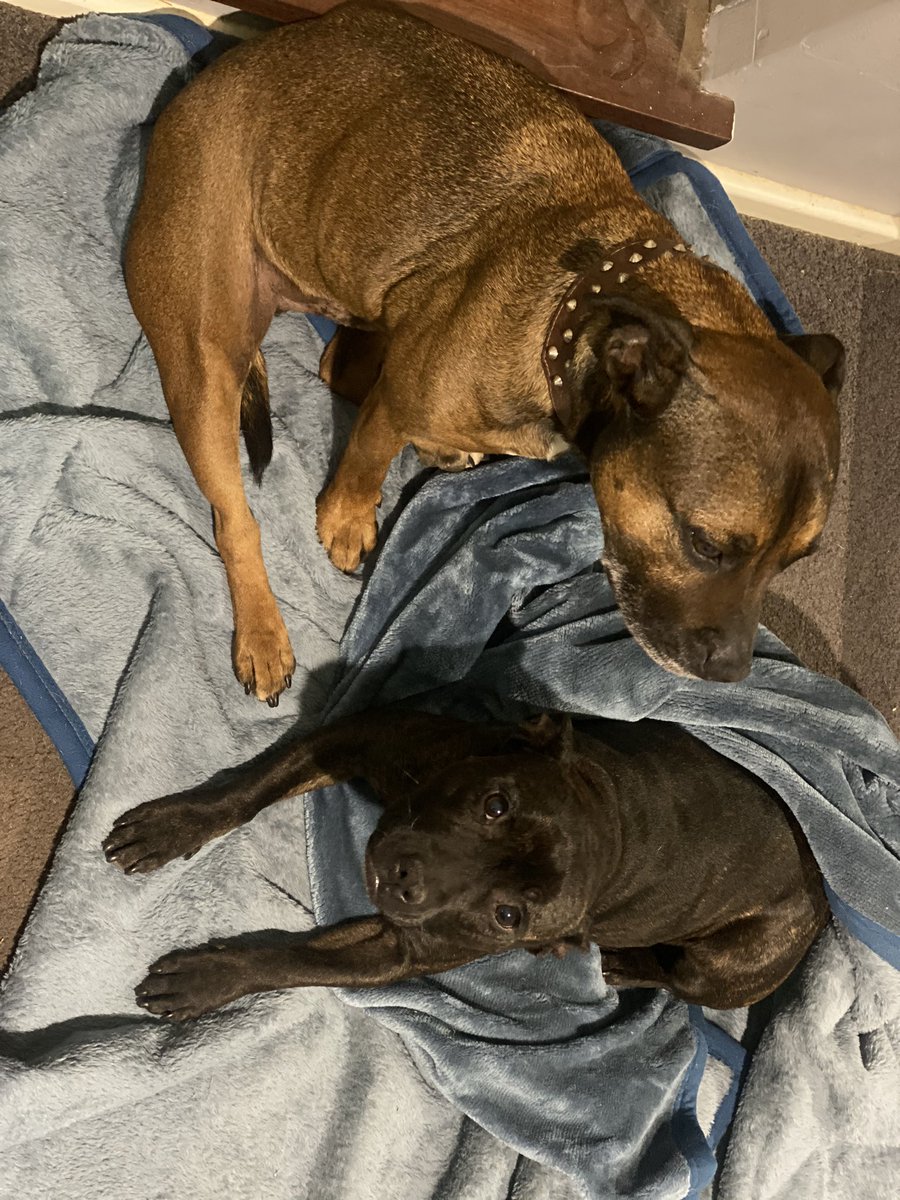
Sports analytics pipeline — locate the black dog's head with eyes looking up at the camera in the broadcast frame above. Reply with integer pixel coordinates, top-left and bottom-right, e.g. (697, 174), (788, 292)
(366, 715), (602, 954)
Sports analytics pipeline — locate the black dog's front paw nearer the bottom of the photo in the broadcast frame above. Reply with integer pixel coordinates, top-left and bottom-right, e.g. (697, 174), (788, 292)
(134, 943), (252, 1021)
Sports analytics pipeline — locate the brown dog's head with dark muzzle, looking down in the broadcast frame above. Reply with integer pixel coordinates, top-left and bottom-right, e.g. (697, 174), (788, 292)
(572, 281), (844, 680)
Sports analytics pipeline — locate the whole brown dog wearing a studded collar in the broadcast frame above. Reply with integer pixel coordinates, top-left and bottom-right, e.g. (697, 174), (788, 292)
(126, 2), (842, 703)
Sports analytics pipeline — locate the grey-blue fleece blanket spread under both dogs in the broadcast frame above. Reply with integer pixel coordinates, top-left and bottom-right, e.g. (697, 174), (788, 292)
(0, 17), (900, 1200)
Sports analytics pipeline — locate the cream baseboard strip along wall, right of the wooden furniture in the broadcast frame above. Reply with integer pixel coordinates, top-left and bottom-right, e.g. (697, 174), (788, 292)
(700, 158), (900, 254)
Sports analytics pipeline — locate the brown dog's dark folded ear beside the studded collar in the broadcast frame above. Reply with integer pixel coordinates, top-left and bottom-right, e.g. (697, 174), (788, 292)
(589, 288), (692, 418)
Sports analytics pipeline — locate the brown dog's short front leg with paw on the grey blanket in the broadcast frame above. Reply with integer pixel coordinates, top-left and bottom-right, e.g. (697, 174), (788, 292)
(316, 376), (404, 571)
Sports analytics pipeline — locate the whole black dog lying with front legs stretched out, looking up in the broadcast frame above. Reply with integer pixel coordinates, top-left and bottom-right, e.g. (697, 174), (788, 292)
(103, 710), (828, 1020)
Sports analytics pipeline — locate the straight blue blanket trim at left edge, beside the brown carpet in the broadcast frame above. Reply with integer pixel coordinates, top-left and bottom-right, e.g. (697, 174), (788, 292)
(0, 600), (94, 787)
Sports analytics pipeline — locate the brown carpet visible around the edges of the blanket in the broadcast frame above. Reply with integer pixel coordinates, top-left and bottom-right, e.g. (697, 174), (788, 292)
(0, 4), (900, 968)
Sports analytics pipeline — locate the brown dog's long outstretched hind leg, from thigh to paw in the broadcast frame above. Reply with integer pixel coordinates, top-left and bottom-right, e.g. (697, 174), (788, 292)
(125, 111), (294, 704)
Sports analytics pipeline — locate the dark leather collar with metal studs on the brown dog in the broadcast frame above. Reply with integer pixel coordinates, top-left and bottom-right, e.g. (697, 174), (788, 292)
(541, 238), (688, 426)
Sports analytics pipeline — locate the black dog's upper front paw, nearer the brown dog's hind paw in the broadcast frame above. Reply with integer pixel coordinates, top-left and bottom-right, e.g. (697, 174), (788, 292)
(103, 796), (226, 875)
